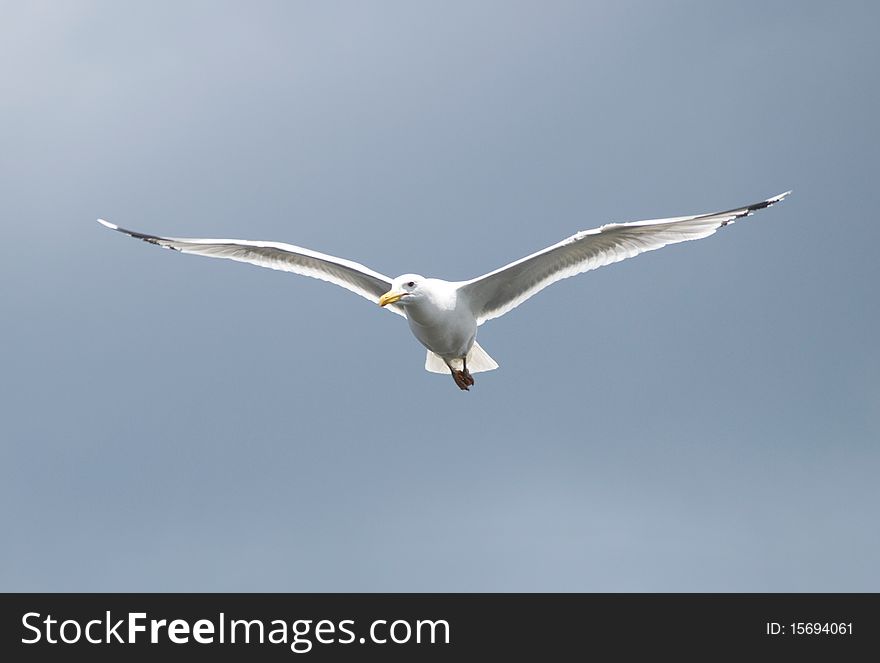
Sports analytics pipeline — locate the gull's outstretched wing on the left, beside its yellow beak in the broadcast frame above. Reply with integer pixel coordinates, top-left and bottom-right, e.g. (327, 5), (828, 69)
(98, 219), (404, 315)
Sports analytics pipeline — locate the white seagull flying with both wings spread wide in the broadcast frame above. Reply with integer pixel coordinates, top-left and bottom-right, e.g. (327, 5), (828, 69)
(98, 191), (791, 391)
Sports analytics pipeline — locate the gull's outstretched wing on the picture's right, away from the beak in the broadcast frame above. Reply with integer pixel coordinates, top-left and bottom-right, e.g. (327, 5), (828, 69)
(460, 191), (791, 324)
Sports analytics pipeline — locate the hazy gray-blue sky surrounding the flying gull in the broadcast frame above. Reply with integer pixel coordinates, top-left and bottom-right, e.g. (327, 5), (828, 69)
(0, 2), (880, 591)
